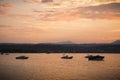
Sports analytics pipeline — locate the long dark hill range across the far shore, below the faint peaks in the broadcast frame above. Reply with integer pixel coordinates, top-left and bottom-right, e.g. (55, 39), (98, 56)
(0, 43), (120, 53)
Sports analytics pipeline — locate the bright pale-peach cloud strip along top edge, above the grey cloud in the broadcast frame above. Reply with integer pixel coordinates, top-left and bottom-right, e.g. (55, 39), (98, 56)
(23, 0), (120, 8)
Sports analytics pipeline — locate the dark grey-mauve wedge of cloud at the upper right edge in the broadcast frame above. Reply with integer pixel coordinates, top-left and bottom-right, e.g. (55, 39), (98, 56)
(72, 3), (120, 19)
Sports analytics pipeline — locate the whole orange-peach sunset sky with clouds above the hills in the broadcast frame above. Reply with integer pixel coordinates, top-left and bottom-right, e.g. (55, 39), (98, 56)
(0, 0), (120, 43)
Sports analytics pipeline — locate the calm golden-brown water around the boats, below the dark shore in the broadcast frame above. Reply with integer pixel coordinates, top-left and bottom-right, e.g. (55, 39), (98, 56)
(0, 54), (120, 80)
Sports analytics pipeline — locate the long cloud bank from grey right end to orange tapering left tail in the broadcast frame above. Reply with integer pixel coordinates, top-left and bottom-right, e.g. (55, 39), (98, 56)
(33, 3), (120, 21)
